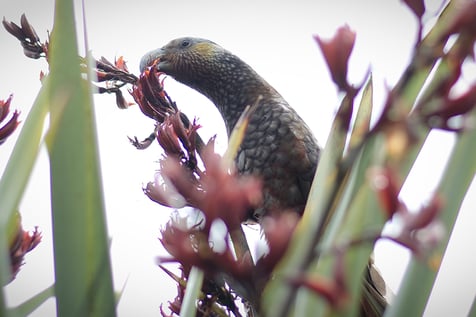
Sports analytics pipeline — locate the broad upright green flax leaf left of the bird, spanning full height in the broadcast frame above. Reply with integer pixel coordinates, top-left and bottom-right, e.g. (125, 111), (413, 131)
(47, 0), (115, 316)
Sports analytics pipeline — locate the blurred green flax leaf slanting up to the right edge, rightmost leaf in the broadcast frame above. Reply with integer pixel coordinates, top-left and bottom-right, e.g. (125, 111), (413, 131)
(385, 110), (476, 317)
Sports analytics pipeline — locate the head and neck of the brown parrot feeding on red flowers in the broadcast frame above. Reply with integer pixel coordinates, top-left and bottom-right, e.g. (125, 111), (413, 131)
(140, 37), (277, 132)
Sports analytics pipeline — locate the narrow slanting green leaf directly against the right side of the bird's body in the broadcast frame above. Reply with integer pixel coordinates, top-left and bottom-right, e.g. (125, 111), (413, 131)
(262, 91), (351, 316)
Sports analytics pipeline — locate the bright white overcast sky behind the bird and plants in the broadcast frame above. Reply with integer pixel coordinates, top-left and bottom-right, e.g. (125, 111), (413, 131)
(0, 0), (476, 316)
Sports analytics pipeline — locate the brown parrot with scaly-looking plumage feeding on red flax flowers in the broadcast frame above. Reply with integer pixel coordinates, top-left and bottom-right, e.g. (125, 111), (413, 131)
(141, 37), (385, 314)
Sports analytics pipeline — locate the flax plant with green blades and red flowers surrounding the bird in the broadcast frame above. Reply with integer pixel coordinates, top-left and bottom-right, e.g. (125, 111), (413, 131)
(0, 0), (476, 317)
